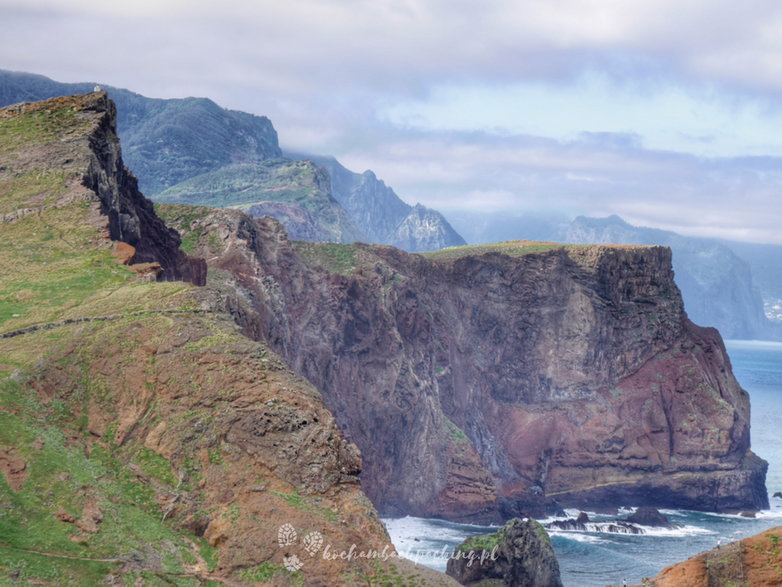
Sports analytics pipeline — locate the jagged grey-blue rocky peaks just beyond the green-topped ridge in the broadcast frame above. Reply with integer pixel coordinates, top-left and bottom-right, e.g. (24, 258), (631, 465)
(289, 153), (467, 252)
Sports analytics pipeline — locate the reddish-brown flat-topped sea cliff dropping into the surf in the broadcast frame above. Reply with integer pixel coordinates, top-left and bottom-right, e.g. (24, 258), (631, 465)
(161, 210), (767, 519)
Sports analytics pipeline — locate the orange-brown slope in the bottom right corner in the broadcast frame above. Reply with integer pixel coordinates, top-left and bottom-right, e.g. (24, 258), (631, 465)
(638, 527), (782, 587)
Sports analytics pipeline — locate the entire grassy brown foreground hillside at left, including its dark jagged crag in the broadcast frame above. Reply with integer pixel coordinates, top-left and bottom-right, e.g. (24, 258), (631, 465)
(0, 92), (460, 585)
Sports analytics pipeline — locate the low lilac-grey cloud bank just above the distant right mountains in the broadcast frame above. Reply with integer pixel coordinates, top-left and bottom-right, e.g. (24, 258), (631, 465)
(344, 126), (782, 243)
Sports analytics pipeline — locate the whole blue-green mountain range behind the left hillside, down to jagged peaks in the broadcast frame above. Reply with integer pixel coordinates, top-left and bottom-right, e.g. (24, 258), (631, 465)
(0, 70), (465, 251)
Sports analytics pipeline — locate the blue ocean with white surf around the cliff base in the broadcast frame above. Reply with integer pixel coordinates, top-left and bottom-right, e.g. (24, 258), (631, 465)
(383, 341), (782, 587)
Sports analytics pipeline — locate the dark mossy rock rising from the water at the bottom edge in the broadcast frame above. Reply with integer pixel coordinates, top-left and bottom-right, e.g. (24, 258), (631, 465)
(446, 518), (562, 587)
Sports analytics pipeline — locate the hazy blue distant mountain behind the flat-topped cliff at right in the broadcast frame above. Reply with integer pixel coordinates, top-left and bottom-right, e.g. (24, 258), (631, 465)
(562, 216), (778, 339)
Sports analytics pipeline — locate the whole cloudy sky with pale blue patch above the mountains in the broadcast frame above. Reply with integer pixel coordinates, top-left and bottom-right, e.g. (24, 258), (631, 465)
(0, 0), (782, 244)
